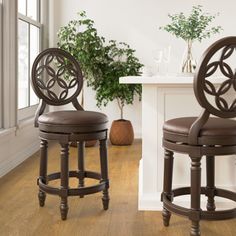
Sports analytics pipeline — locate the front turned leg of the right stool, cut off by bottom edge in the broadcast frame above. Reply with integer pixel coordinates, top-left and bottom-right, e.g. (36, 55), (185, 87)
(189, 157), (201, 236)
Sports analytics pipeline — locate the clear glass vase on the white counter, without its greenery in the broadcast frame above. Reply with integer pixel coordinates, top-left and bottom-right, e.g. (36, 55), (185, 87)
(182, 40), (196, 74)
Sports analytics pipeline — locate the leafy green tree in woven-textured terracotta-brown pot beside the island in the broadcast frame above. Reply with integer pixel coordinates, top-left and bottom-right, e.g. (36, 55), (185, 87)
(92, 40), (143, 145)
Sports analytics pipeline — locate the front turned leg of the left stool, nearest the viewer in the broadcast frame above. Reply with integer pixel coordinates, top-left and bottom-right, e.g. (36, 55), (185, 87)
(60, 143), (69, 220)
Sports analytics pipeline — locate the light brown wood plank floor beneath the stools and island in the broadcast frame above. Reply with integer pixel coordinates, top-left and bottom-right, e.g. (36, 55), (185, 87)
(0, 141), (236, 236)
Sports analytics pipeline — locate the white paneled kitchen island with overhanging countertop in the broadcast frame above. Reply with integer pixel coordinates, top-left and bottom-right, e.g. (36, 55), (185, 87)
(120, 76), (236, 210)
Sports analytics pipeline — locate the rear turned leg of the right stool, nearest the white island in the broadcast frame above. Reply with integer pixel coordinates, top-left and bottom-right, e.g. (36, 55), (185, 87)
(206, 156), (216, 211)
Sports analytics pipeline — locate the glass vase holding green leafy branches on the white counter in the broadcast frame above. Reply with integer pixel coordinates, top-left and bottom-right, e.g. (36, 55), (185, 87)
(160, 5), (222, 73)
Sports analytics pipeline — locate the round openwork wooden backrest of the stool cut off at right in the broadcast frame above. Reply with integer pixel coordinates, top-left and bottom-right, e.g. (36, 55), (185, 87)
(194, 37), (236, 118)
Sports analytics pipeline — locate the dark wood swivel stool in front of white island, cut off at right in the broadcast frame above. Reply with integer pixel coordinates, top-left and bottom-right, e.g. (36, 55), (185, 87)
(162, 37), (236, 236)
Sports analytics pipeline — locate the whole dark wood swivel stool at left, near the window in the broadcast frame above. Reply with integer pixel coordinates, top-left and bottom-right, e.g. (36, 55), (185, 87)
(31, 48), (109, 220)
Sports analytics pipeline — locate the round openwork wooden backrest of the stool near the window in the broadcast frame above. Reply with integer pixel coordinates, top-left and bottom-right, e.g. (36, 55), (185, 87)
(31, 48), (83, 106)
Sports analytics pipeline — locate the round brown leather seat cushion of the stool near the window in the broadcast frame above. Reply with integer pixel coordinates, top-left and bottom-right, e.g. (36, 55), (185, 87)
(38, 111), (108, 133)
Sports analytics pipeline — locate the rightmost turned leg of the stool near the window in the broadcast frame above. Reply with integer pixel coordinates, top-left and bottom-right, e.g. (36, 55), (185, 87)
(100, 139), (110, 210)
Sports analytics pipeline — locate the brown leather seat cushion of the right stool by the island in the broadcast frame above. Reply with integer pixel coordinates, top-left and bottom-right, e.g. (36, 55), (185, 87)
(163, 117), (236, 144)
